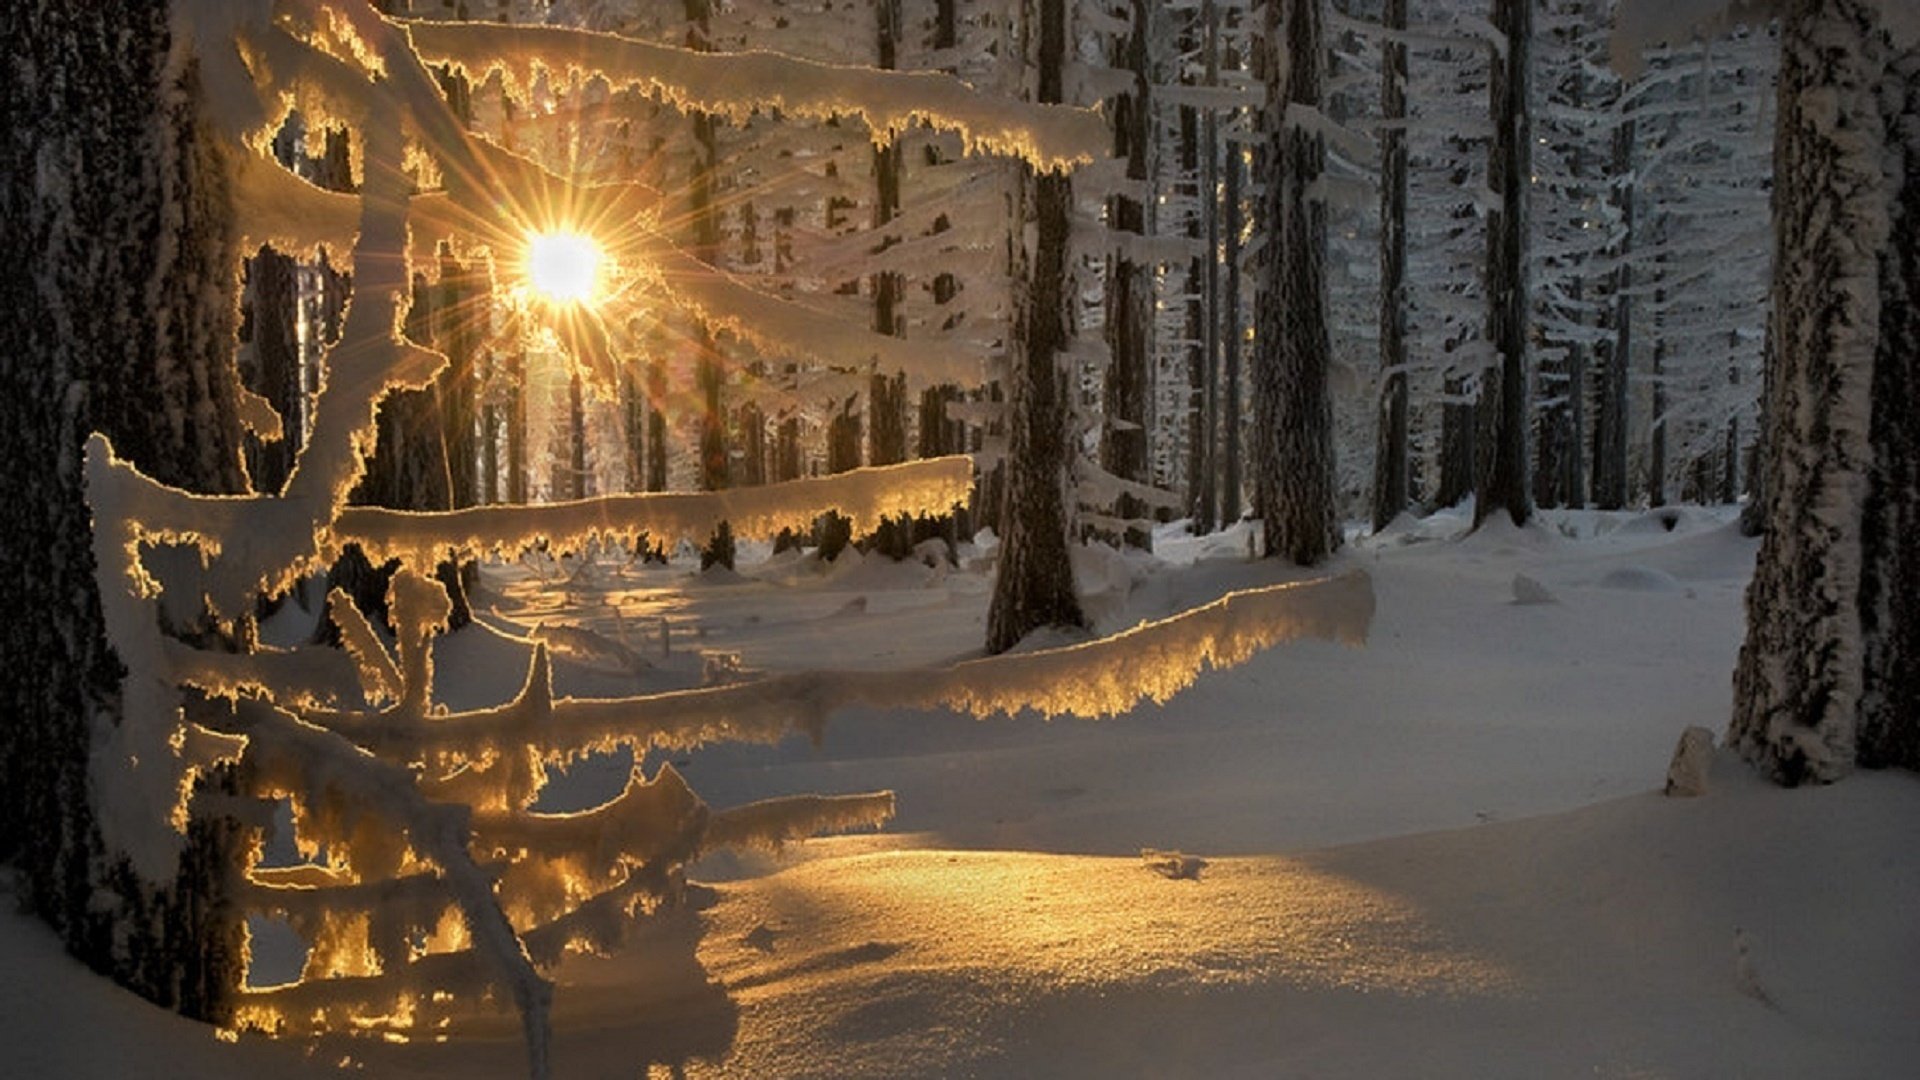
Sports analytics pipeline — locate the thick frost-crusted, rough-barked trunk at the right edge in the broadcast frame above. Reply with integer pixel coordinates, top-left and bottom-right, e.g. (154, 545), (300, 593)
(1728, 0), (1920, 784)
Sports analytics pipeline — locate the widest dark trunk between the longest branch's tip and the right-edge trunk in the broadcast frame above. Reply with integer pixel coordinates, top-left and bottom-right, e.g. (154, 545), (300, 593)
(1473, 0), (1532, 525)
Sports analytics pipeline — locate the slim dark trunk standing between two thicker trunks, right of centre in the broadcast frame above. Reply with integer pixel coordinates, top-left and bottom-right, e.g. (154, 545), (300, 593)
(1373, 0), (1411, 532)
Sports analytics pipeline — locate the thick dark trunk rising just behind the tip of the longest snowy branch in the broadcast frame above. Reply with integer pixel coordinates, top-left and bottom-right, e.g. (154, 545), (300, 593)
(1254, 0), (1340, 567)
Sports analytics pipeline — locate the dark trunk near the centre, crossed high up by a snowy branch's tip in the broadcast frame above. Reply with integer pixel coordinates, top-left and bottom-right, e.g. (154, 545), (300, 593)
(987, 0), (1087, 653)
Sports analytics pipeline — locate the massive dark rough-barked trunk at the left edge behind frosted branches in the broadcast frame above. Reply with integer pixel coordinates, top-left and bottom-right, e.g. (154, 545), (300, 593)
(0, 0), (246, 1020)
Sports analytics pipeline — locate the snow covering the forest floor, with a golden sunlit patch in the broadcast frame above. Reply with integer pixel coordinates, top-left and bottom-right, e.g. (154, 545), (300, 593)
(0, 509), (1920, 1078)
